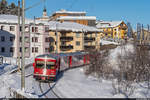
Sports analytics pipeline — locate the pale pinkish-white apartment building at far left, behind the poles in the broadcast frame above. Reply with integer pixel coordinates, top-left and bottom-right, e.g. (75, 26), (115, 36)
(0, 15), (49, 57)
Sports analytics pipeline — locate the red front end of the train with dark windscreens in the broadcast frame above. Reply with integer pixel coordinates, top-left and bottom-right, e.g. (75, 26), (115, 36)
(33, 55), (57, 81)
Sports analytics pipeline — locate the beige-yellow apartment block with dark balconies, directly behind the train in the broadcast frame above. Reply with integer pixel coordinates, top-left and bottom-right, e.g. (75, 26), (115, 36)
(49, 21), (100, 53)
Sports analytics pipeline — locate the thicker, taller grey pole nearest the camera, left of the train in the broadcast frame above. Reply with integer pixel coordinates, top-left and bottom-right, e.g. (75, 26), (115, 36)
(21, 0), (25, 91)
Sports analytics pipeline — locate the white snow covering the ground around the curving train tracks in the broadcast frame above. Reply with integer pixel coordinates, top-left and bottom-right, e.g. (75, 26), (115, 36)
(0, 42), (150, 98)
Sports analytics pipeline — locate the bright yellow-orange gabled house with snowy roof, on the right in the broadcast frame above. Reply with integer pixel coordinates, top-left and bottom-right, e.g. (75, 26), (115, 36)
(96, 21), (128, 39)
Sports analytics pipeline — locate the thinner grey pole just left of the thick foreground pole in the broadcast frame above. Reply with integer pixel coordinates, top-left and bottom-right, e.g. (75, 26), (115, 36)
(17, 0), (20, 71)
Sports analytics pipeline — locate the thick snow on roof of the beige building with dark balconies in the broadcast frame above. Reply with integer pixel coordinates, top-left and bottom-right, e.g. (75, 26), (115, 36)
(49, 21), (100, 32)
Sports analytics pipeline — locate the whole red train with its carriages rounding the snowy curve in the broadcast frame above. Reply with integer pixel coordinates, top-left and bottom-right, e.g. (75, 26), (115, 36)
(33, 52), (89, 81)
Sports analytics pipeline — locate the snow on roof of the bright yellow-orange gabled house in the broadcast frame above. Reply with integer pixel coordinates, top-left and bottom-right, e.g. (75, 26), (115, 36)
(96, 21), (123, 28)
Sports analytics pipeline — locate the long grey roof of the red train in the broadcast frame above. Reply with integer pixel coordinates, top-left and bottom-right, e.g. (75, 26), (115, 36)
(36, 52), (86, 59)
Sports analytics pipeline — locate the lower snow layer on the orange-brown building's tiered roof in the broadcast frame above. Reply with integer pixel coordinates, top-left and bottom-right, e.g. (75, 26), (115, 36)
(57, 16), (96, 20)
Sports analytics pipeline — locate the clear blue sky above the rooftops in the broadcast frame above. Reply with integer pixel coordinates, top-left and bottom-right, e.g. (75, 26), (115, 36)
(7, 0), (150, 27)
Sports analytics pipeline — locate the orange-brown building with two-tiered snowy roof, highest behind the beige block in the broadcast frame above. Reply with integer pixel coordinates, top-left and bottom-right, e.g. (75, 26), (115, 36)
(50, 10), (96, 26)
